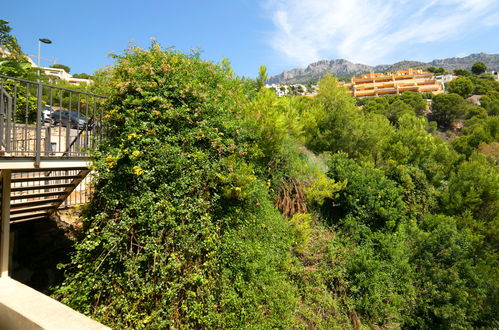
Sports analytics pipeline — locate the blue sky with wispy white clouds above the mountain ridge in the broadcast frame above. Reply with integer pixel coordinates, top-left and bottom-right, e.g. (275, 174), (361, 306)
(0, 0), (499, 77)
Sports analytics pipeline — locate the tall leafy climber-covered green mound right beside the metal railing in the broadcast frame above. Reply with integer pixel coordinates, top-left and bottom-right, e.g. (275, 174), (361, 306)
(58, 44), (302, 328)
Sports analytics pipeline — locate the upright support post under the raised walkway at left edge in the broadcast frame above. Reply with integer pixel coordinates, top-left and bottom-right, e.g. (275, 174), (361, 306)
(0, 170), (11, 278)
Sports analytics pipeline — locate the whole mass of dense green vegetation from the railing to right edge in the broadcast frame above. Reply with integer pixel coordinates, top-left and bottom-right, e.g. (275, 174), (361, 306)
(51, 44), (499, 329)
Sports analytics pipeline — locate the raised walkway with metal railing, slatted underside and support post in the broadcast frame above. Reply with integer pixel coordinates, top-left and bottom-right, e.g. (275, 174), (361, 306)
(0, 74), (106, 280)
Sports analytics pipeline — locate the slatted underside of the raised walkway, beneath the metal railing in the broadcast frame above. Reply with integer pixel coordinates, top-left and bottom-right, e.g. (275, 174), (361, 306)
(2, 167), (90, 224)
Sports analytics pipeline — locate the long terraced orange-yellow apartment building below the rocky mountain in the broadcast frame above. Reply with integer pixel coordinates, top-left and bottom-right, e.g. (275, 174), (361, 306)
(340, 69), (444, 97)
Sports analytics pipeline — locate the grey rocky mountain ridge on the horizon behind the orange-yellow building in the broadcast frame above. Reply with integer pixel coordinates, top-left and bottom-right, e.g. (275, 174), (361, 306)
(267, 53), (499, 84)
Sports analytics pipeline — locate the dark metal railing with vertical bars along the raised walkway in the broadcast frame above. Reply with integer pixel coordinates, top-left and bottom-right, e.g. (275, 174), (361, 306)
(0, 75), (105, 163)
